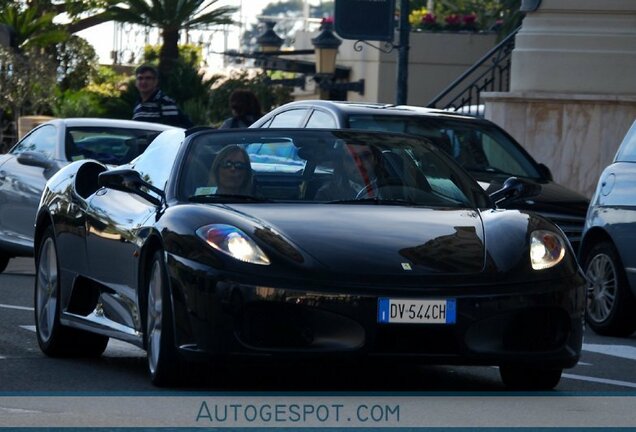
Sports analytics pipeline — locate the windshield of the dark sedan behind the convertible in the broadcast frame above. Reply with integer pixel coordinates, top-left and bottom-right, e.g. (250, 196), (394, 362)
(349, 114), (541, 179)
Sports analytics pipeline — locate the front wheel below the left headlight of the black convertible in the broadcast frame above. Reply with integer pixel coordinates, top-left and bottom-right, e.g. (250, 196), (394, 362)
(146, 251), (183, 387)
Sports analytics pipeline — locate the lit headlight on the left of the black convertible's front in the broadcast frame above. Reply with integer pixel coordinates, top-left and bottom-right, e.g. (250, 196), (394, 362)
(196, 224), (269, 265)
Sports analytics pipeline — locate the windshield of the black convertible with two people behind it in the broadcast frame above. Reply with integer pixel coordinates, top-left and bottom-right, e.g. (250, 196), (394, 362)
(177, 129), (488, 208)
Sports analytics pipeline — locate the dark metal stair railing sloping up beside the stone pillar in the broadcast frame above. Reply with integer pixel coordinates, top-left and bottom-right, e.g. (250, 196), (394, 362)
(427, 27), (519, 113)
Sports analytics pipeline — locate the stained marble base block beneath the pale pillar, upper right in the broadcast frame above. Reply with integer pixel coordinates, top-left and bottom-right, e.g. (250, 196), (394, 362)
(483, 92), (636, 197)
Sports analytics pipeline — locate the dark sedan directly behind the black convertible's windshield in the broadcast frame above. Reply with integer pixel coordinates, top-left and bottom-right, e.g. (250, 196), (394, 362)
(251, 100), (589, 250)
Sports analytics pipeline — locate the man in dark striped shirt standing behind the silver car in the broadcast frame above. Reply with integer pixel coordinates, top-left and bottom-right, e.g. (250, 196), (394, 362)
(132, 65), (192, 128)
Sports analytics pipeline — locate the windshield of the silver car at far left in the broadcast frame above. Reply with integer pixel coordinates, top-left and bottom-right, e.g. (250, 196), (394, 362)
(65, 126), (161, 165)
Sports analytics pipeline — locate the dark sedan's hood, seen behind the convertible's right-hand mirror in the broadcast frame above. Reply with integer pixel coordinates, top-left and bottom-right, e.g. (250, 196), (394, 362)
(471, 173), (590, 219)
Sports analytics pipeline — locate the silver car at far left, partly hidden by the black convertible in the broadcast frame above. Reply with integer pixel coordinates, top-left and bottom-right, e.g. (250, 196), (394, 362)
(0, 118), (174, 272)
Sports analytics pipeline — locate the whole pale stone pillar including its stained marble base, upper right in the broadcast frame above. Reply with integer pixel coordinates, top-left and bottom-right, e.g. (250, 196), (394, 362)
(482, 0), (636, 196)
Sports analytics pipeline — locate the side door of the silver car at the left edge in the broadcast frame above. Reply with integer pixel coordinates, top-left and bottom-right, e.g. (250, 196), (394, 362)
(0, 124), (61, 250)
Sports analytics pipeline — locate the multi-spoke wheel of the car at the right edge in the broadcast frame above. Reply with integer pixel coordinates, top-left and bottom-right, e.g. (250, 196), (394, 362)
(583, 242), (636, 336)
